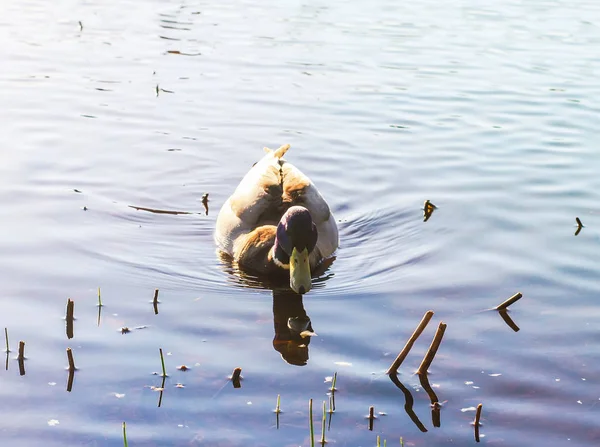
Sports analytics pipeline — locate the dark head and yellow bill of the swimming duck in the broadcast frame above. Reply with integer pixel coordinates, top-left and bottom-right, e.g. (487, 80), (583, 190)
(273, 206), (318, 295)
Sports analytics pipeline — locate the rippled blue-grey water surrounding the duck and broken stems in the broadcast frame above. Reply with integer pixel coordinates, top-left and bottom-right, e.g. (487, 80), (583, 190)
(0, 0), (600, 447)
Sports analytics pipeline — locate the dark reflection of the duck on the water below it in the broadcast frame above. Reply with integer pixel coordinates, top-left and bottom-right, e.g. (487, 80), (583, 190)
(217, 251), (335, 366)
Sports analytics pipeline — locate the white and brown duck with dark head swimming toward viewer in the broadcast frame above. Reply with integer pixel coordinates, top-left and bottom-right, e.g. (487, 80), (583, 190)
(215, 144), (338, 294)
